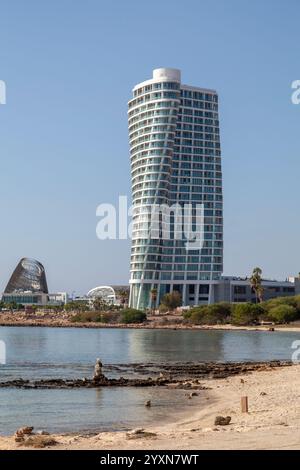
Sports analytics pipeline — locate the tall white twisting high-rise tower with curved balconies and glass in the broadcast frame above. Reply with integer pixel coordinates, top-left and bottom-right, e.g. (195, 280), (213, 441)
(128, 68), (223, 308)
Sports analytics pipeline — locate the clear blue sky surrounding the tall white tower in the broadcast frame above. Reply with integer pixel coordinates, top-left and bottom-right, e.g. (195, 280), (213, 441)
(0, 0), (300, 293)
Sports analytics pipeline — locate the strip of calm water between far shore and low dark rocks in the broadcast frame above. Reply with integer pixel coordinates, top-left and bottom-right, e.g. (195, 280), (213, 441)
(0, 327), (300, 376)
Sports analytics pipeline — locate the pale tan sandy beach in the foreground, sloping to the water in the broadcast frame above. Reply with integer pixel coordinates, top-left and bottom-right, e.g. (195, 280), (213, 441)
(0, 365), (300, 450)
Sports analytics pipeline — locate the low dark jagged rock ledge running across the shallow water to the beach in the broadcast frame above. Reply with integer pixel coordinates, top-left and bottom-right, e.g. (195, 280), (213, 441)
(0, 361), (292, 390)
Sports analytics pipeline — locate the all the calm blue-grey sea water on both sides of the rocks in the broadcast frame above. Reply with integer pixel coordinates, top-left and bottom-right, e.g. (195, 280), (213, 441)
(0, 327), (300, 435)
